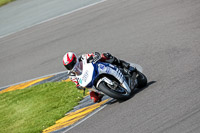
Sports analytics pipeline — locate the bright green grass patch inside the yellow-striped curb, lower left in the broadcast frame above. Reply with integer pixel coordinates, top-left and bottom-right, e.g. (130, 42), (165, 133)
(0, 82), (83, 133)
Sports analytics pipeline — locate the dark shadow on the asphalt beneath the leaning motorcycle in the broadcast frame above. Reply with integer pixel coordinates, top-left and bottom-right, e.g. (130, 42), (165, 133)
(107, 81), (156, 104)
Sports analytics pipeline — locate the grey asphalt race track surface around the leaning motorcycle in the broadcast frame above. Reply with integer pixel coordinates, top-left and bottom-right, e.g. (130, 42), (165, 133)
(0, 0), (200, 133)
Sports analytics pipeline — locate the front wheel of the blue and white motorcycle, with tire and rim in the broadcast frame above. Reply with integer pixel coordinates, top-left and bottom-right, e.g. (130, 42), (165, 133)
(99, 81), (131, 100)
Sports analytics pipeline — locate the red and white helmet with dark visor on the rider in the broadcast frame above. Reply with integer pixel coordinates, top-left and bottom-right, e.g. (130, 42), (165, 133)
(63, 52), (78, 70)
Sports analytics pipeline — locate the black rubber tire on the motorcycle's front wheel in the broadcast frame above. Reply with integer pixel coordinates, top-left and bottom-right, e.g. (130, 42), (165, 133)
(98, 81), (131, 100)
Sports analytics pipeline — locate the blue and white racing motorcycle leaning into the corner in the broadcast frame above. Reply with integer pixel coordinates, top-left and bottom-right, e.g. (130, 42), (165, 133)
(73, 53), (147, 100)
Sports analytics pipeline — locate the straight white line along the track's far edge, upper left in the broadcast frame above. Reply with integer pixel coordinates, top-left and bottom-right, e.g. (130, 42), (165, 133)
(0, 0), (107, 39)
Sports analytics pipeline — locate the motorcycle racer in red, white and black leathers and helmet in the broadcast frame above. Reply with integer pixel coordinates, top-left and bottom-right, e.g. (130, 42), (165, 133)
(63, 52), (130, 103)
